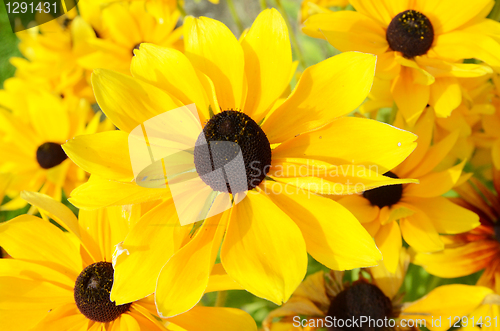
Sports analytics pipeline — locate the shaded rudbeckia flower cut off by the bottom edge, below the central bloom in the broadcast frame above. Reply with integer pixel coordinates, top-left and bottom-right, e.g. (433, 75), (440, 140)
(263, 250), (409, 331)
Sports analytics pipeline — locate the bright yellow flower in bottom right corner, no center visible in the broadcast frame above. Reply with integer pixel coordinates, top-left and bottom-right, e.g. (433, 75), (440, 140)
(403, 284), (500, 331)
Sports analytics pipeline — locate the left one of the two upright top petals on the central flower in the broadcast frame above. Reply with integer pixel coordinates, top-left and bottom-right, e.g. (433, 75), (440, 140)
(184, 17), (245, 110)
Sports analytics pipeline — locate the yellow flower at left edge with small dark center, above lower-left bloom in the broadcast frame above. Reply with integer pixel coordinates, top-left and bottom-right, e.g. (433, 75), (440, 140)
(0, 89), (113, 210)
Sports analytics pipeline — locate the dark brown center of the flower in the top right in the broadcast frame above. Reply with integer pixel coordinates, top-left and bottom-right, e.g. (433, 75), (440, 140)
(386, 9), (434, 59)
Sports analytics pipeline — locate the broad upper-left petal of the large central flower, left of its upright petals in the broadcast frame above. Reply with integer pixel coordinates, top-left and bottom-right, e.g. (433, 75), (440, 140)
(92, 69), (182, 132)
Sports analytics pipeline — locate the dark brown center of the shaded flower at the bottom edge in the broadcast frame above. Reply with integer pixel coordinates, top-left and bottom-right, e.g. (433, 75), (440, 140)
(327, 282), (392, 331)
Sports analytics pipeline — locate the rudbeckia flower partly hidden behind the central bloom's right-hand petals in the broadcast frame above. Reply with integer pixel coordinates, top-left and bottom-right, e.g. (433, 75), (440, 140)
(338, 111), (479, 272)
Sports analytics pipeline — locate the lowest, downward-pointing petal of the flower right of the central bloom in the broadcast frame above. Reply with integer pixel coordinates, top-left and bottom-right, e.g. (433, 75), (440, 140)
(375, 222), (403, 273)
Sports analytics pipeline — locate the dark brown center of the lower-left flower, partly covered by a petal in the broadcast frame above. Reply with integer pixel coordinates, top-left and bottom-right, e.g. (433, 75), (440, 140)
(74, 262), (132, 323)
